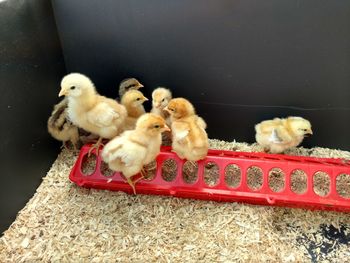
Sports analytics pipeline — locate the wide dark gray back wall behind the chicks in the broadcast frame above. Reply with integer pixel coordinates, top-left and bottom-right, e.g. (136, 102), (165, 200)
(53, 0), (350, 150)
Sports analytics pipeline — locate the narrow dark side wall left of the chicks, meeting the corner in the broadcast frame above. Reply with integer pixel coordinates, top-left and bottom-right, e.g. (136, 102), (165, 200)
(0, 0), (65, 235)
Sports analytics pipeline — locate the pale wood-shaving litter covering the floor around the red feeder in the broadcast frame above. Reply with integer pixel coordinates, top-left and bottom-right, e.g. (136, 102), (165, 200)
(0, 140), (350, 262)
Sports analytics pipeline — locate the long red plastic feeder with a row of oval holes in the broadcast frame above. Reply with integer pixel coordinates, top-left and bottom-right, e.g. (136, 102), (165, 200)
(69, 145), (350, 212)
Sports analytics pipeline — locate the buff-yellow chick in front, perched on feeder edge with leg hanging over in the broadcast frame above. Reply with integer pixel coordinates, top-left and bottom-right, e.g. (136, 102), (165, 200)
(102, 113), (169, 194)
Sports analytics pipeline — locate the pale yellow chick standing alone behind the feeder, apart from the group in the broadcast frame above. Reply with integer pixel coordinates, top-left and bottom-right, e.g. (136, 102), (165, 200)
(255, 117), (312, 153)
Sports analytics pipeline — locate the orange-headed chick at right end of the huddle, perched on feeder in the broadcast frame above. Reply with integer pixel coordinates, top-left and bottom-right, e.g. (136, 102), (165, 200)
(165, 98), (209, 161)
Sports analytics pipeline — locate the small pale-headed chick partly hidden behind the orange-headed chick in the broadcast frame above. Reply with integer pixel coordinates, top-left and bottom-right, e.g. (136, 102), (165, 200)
(151, 87), (172, 146)
